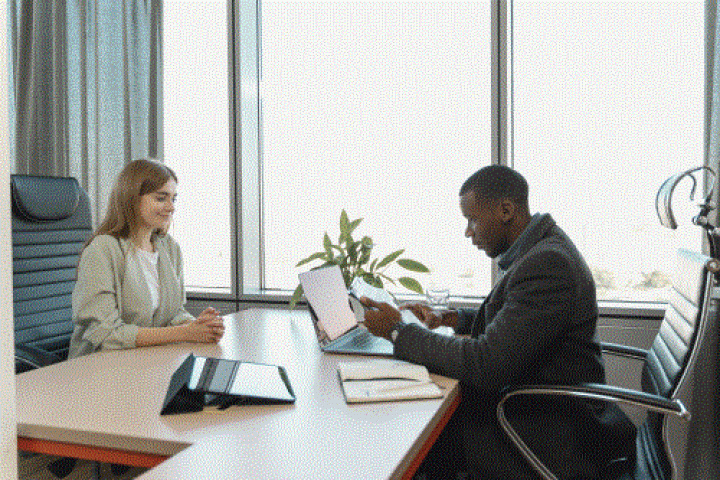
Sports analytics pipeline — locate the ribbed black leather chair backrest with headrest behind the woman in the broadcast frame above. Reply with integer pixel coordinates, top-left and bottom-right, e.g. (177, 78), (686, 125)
(10, 175), (92, 371)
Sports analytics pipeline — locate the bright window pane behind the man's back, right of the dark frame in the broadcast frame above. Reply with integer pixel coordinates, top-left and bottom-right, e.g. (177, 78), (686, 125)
(512, 0), (705, 301)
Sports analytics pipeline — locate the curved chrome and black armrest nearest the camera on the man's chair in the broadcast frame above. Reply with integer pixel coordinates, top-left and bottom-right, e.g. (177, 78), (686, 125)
(497, 383), (690, 480)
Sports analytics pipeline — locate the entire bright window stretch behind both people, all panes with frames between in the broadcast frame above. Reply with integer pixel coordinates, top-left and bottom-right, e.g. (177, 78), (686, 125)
(163, 0), (704, 301)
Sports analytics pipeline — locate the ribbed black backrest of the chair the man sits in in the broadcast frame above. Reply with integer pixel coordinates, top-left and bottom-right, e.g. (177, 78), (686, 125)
(638, 250), (718, 478)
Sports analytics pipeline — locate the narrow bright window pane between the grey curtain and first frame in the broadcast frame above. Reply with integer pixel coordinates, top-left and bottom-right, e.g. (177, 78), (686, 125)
(163, 0), (232, 293)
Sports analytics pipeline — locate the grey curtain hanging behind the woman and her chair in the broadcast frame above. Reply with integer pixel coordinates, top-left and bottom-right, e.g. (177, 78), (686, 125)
(8, 0), (162, 225)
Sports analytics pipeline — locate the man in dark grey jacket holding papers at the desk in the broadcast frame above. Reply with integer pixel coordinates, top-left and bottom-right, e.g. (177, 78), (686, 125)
(363, 165), (634, 479)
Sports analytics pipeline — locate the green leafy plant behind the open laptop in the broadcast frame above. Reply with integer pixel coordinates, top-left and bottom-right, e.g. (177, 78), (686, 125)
(290, 210), (430, 308)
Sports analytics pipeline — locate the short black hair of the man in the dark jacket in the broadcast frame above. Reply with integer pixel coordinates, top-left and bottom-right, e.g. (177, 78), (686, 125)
(460, 165), (528, 207)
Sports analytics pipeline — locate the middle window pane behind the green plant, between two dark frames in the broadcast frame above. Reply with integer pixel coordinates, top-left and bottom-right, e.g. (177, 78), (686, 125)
(261, 0), (491, 296)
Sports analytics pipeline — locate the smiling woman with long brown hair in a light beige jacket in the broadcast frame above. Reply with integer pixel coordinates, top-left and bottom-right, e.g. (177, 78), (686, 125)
(69, 160), (225, 358)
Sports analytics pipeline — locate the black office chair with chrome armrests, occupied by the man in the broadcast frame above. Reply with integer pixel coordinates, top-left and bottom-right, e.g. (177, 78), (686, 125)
(497, 167), (720, 480)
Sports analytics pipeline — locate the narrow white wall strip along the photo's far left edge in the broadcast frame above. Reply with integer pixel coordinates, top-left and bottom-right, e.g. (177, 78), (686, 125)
(0, 0), (17, 480)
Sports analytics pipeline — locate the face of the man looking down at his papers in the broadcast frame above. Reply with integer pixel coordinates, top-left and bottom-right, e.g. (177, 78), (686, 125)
(460, 190), (510, 258)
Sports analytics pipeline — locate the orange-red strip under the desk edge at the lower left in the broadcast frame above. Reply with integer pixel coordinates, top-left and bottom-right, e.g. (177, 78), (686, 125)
(17, 437), (168, 468)
